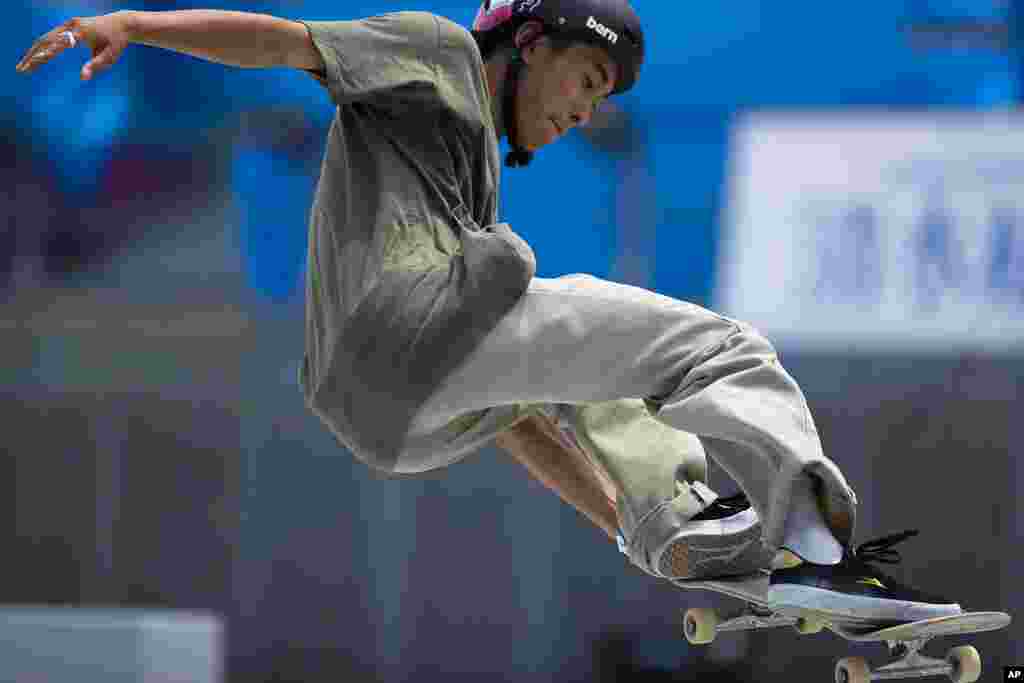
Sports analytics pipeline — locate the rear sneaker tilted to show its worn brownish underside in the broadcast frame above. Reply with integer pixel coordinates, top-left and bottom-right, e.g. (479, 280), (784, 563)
(654, 493), (771, 580)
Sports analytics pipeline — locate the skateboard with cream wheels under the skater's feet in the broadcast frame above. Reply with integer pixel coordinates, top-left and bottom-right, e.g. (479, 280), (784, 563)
(673, 572), (1011, 683)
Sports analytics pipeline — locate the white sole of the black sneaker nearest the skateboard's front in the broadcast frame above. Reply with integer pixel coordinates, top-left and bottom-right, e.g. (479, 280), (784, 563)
(766, 584), (963, 623)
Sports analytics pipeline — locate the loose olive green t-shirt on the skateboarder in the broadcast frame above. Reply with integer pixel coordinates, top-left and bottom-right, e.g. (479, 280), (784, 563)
(301, 12), (536, 470)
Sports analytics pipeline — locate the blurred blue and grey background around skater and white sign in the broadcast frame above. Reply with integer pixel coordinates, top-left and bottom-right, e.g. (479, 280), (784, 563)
(0, 0), (1024, 682)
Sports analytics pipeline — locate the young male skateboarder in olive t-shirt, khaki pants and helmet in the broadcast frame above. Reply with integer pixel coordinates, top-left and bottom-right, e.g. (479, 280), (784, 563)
(18, 0), (961, 622)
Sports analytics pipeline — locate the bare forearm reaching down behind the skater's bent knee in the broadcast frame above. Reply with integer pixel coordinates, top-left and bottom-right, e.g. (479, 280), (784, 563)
(498, 416), (618, 541)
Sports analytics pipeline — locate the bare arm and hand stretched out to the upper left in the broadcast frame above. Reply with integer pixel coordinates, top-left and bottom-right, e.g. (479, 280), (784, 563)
(17, 9), (324, 80)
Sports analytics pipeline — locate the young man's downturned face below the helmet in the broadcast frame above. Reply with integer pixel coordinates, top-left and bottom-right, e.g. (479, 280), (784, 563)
(516, 37), (616, 152)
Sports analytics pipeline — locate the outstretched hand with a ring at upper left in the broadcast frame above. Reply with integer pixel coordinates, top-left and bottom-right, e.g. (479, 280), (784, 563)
(17, 12), (131, 81)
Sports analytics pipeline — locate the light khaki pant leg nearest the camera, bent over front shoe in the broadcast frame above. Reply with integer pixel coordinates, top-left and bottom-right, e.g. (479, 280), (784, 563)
(399, 275), (856, 550)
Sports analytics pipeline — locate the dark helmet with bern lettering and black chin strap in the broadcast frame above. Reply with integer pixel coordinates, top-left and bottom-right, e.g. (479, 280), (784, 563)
(472, 0), (644, 166)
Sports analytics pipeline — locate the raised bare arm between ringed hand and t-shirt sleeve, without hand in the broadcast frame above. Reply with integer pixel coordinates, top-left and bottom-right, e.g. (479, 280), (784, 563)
(128, 9), (324, 71)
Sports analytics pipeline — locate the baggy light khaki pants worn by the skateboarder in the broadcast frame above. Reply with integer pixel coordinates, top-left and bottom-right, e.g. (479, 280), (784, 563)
(396, 275), (856, 569)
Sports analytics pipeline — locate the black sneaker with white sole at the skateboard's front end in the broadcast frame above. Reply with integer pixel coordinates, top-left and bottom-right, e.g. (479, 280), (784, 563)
(767, 530), (963, 626)
